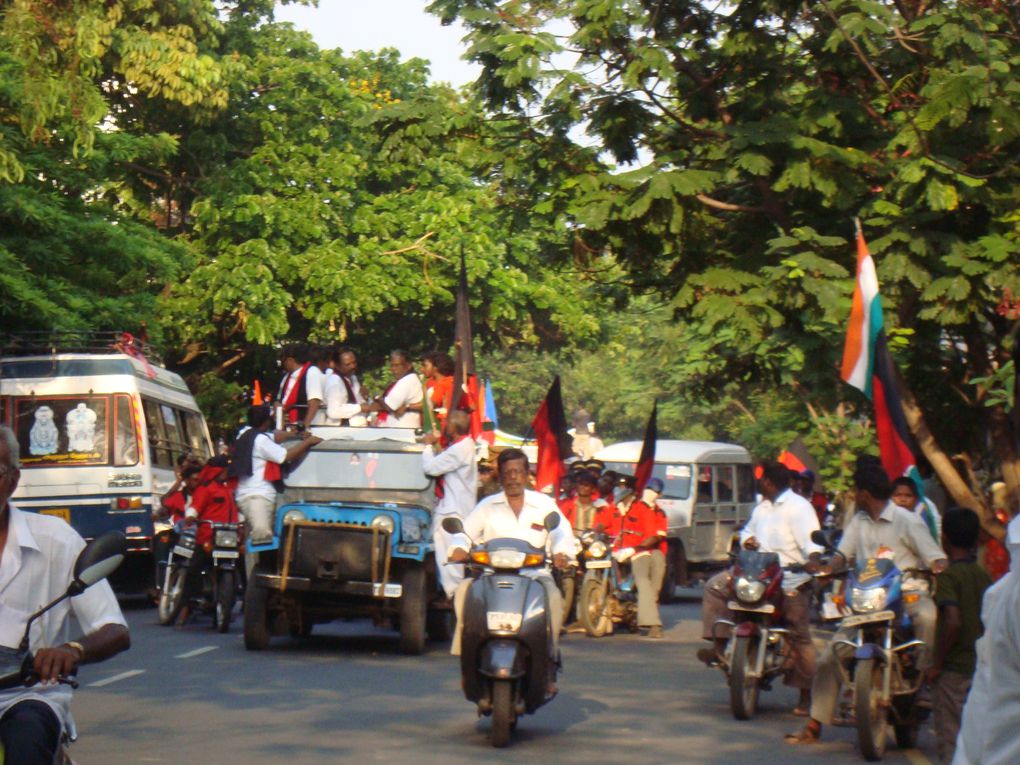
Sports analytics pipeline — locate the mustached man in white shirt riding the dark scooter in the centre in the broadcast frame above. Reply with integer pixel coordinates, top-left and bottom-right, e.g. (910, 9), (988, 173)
(450, 449), (574, 656)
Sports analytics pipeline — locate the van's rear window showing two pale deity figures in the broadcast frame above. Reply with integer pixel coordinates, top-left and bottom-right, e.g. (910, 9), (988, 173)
(13, 395), (110, 468)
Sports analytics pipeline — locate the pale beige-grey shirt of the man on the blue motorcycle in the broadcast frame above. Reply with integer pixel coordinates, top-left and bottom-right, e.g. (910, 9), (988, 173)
(839, 501), (946, 592)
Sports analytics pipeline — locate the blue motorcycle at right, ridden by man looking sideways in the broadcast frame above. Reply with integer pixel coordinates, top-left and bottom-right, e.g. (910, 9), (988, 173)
(812, 531), (928, 761)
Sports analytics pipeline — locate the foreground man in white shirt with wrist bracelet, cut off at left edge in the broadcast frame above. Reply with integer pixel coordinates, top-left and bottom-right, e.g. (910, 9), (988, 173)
(0, 426), (131, 765)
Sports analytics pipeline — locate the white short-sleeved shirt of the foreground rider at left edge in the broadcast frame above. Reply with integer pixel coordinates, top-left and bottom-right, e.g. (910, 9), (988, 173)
(0, 505), (128, 724)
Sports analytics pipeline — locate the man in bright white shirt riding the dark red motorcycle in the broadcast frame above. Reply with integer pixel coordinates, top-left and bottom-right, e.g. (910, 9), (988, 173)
(698, 462), (822, 715)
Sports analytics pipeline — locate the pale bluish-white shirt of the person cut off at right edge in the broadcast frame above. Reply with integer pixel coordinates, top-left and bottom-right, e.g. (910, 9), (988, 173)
(953, 517), (1020, 765)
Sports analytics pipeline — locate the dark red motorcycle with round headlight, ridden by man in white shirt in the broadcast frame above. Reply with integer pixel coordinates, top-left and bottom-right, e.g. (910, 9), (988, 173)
(712, 550), (803, 720)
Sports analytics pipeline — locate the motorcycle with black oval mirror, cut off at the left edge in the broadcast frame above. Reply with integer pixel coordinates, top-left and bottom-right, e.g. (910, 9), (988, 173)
(0, 531), (128, 765)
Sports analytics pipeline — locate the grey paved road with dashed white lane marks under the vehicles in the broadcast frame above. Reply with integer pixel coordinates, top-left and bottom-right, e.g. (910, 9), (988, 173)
(67, 600), (935, 765)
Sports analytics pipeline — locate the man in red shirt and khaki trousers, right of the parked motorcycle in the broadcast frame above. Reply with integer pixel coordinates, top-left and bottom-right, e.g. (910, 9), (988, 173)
(616, 478), (666, 640)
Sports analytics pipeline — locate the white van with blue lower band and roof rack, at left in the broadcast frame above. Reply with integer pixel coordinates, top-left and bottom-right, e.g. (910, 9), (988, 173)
(0, 333), (212, 571)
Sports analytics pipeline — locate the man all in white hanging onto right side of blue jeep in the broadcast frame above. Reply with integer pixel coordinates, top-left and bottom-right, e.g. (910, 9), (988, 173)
(421, 410), (478, 598)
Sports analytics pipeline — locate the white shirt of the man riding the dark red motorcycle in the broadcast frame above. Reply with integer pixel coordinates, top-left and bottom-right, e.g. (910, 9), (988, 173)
(741, 489), (824, 590)
